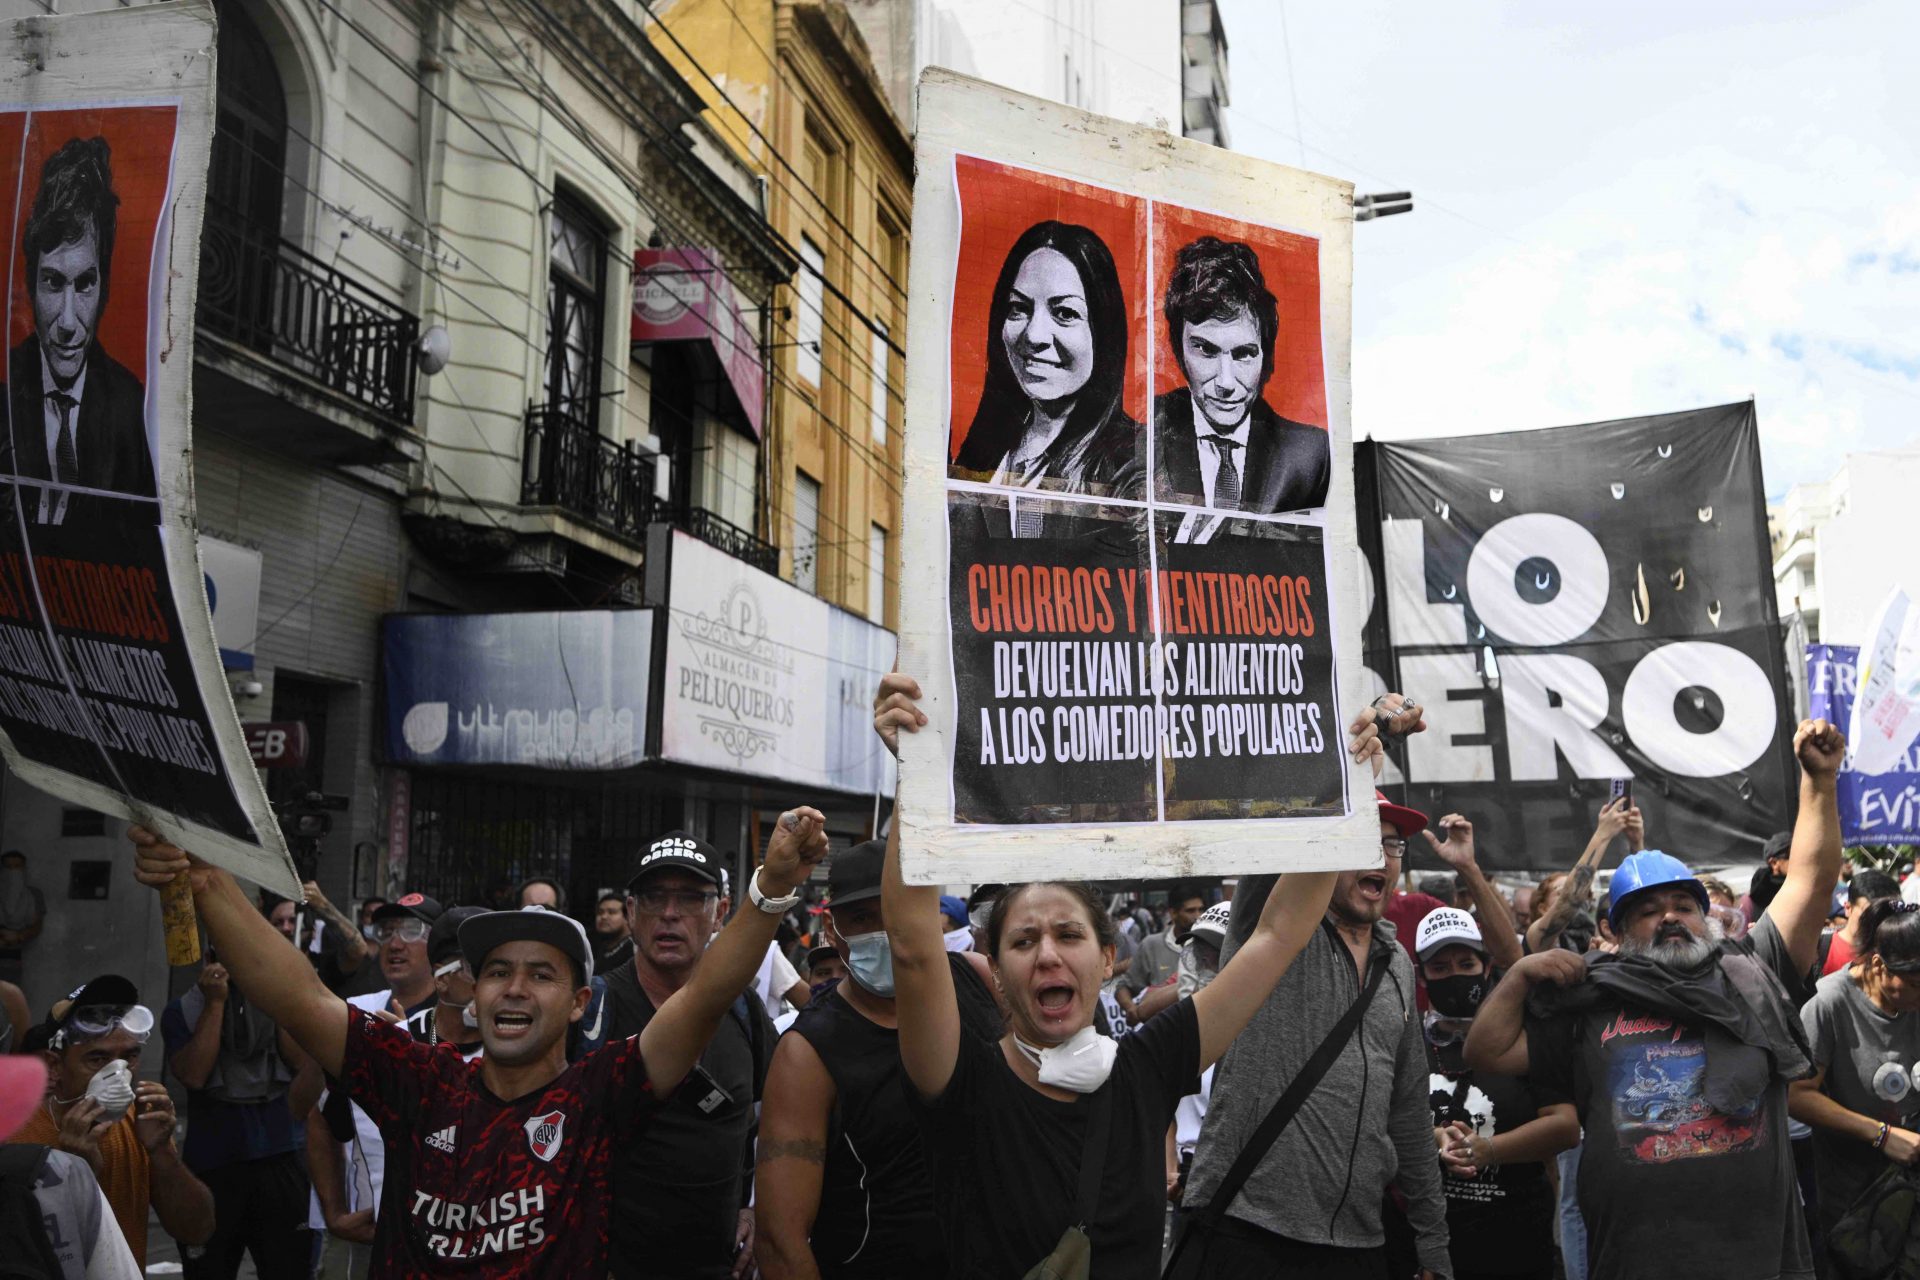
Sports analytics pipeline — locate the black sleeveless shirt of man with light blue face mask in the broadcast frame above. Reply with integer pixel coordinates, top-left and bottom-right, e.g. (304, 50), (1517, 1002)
(793, 956), (1000, 1280)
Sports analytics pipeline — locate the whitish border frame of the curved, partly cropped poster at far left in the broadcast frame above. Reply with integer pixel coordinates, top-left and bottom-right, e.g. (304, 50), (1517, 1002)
(0, 0), (301, 902)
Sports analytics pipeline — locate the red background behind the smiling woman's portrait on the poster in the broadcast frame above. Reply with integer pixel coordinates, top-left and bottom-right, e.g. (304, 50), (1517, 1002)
(947, 155), (1146, 459)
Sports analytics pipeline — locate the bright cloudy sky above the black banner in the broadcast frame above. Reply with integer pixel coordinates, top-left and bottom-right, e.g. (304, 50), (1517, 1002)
(1219, 0), (1920, 495)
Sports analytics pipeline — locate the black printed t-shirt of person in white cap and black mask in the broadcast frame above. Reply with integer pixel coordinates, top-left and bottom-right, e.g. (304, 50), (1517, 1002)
(1427, 1038), (1567, 1276)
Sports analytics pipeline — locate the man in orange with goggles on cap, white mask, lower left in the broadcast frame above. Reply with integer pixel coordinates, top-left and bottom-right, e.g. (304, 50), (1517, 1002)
(10, 973), (213, 1268)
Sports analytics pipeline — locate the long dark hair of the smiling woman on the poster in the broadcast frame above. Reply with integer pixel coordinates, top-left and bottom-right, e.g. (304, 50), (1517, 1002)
(954, 221), (1127, 472)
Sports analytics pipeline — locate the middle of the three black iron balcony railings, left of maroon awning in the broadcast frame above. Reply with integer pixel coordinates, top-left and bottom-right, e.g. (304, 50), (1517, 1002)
(520, 403), (655, 539)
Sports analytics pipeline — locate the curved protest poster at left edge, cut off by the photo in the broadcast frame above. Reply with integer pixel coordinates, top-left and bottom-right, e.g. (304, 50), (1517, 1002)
(0, 4), (300, 896)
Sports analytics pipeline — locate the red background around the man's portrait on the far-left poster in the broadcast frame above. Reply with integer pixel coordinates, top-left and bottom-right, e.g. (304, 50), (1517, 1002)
(0, 107), (179, 384)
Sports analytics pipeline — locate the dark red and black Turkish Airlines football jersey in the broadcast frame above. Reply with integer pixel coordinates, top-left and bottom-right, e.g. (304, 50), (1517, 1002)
(342, 1009), (668, 1280)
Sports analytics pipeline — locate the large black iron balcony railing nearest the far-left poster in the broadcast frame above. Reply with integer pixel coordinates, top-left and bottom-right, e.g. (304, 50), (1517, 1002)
(198, 209), (420, 426)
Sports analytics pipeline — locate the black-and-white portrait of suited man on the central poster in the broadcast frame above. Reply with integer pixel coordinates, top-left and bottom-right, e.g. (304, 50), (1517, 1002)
(1154, 236), (1331, 514)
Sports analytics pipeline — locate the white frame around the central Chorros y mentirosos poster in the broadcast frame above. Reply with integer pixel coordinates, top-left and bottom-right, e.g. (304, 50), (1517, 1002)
(899, 67), (1380, 885)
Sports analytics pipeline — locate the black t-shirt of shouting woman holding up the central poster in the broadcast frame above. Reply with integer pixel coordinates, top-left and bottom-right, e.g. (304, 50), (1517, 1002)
(908, 1000), (1200, 1280)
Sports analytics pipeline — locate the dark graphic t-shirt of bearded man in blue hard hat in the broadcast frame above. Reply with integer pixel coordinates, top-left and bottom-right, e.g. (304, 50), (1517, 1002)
(1526, 917), (1814, 1280)
